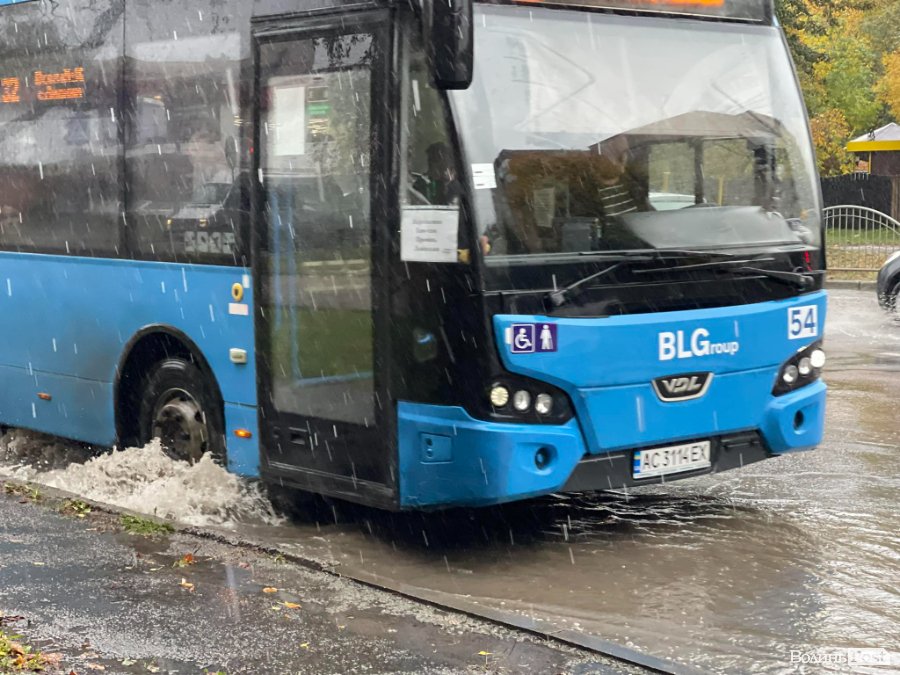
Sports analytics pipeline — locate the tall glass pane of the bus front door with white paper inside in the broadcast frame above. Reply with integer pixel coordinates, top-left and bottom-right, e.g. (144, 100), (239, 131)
(260, 35), (374, 424)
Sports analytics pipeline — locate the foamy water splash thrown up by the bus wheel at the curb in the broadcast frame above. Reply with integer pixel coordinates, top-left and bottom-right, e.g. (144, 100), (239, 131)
(0, 429), (281, 527)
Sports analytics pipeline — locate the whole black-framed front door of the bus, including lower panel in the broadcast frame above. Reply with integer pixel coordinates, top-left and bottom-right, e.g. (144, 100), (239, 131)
(255, 15), (393, 506)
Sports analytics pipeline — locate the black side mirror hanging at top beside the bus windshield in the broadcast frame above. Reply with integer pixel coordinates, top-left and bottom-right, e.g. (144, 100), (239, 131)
(430, 0), (474, 89)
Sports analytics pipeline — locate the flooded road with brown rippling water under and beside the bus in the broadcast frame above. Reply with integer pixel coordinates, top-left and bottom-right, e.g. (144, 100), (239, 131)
(3, 290), (900, 673)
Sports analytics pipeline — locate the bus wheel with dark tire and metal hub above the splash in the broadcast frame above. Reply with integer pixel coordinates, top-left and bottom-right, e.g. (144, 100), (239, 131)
(138, 357), (225, 464)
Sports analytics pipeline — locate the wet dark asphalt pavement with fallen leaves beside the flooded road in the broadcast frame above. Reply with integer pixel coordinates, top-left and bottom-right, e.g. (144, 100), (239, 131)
(0, 494), (637, 675)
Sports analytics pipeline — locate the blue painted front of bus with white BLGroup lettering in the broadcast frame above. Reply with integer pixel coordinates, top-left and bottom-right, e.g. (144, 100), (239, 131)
(398, 291), (826, 507)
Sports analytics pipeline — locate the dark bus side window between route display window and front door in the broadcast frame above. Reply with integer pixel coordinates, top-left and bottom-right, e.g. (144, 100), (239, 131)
(126, 0), (251, 264)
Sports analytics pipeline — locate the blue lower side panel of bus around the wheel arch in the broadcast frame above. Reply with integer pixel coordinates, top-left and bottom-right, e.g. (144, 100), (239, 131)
(0, 252), (258, 474)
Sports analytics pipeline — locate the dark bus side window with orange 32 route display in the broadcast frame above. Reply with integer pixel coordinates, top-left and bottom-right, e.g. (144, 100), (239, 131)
(0, 0), (123, 255)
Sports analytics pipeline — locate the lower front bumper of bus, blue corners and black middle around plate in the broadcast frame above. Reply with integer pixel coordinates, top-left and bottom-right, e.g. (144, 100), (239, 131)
(398, 381), (826, 509)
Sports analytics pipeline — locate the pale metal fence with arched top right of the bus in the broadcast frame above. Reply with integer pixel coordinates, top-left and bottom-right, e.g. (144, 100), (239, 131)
(824, 206), (900, 277)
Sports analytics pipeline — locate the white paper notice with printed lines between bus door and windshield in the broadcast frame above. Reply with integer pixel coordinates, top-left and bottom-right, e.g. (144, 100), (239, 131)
(400, 206), (459, 263)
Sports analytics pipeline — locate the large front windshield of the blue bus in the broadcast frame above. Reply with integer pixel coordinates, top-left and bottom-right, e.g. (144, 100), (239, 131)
(452, 6), (821, 265)
